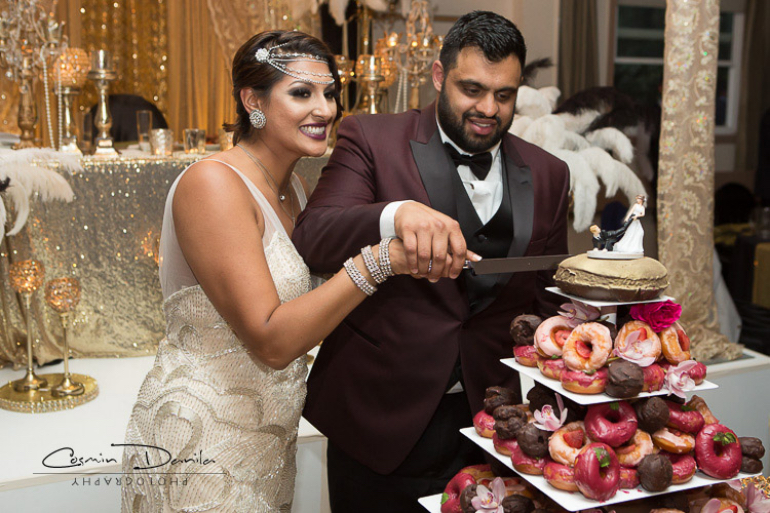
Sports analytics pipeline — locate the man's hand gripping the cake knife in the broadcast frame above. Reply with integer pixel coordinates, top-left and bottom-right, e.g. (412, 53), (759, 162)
(394, 201), (468, 281)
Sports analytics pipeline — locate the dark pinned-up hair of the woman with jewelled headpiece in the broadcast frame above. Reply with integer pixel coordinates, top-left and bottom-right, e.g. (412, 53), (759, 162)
(222, 30), (342, 144)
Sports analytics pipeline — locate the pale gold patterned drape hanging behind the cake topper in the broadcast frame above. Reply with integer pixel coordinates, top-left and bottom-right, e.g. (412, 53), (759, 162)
(658, 0), (742, 360)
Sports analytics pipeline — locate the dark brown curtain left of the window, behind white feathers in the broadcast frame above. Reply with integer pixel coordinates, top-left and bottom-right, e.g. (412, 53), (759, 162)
(558, 0), (599, 99)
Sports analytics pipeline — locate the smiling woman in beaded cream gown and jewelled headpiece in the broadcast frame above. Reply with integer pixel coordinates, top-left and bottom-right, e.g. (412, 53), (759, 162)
(122, 31), (464, 512)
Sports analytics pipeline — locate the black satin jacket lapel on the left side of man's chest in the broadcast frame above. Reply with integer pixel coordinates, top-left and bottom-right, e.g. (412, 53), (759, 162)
(409, 130), (457, 219)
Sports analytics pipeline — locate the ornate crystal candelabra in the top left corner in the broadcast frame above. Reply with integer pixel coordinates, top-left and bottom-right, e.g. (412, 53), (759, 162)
(0, 0), (67, 149)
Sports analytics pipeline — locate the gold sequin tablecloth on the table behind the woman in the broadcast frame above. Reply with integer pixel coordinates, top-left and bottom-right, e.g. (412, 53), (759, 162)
(0, 152), (326, 364)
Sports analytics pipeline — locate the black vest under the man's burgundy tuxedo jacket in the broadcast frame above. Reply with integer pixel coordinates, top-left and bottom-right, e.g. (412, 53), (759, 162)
(450, 156), (513, 315)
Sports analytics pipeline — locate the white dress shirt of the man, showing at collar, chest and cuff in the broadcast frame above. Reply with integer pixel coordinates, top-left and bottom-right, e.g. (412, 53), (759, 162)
(380, 120), (503, 238)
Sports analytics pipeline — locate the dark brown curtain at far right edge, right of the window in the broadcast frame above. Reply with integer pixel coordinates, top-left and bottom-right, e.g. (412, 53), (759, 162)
(735, 0), (770, 179)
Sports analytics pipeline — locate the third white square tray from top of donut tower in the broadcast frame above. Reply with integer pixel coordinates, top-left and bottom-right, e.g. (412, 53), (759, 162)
(460, 427), (759, 511)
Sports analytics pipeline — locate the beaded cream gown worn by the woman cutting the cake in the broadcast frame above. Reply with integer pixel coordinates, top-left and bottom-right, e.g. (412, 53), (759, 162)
(122, 158), (311, 513)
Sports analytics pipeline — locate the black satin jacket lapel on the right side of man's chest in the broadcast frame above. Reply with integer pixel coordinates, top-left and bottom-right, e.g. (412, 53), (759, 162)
(505, 154), (535, 257)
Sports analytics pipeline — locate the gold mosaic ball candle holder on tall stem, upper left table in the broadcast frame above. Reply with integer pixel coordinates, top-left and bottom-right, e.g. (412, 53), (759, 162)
(52, 48), (90, 155)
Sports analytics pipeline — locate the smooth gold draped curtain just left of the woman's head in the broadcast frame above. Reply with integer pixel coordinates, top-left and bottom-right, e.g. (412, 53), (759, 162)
(167, 0), (235, 139)
